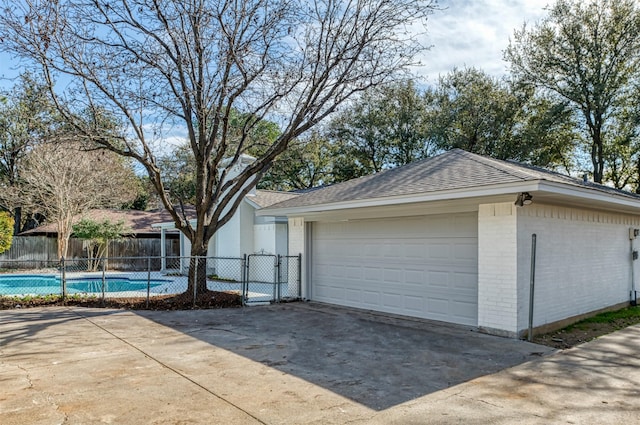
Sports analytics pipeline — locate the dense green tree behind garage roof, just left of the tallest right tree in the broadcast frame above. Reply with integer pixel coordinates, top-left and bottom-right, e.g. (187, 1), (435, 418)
(427, 68), (575, 168)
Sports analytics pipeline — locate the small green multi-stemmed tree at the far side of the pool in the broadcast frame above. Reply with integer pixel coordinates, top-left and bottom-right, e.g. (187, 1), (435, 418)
(73, 218), (130, 271)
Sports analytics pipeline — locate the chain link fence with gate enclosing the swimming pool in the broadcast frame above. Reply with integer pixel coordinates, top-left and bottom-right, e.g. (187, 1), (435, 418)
(0, 254), (301, 308)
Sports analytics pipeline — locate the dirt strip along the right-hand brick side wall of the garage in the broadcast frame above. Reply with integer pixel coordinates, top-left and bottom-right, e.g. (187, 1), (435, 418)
(533, 318), (639, 349)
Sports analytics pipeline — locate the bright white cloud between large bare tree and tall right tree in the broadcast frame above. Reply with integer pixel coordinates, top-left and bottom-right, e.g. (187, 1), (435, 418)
(415, 0), (552, 84)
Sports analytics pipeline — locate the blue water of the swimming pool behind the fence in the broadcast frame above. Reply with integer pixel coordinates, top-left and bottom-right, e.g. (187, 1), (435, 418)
(0, 275), (169, 295)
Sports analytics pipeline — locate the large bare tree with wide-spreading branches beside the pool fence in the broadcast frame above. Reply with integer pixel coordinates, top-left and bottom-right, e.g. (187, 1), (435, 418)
(0, 0), (437, 291)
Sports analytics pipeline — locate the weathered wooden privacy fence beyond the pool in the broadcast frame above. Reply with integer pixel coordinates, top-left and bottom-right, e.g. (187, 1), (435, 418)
(0, 236), (180, 267)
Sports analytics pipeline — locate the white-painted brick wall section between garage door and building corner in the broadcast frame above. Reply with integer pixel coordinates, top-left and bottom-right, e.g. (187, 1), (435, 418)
(478, 202), (518, 336)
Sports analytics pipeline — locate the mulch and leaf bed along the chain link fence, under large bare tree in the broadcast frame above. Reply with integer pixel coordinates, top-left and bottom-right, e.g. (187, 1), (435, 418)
(0, 291), (242, 310)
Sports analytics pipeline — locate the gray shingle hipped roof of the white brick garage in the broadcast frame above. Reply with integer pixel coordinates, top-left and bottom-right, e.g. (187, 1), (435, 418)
(262, 149), (640, 208)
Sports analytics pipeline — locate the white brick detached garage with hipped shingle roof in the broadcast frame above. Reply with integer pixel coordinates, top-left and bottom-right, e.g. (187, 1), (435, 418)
(257, 149), (640, 337)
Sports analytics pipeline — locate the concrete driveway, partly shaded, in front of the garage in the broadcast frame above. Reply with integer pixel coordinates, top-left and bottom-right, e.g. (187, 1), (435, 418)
(0, 303), (640, 425)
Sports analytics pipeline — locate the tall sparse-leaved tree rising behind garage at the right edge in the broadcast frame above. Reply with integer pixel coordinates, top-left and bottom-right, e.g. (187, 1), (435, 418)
(505, 0), (640, 183)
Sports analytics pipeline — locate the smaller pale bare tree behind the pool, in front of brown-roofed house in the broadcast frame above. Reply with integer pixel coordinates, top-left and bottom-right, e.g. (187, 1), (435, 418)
(19, 143), (136, 257)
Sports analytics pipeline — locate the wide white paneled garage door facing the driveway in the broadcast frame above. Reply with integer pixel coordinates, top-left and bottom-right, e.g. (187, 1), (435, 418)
(311, 213), (478, 325)
